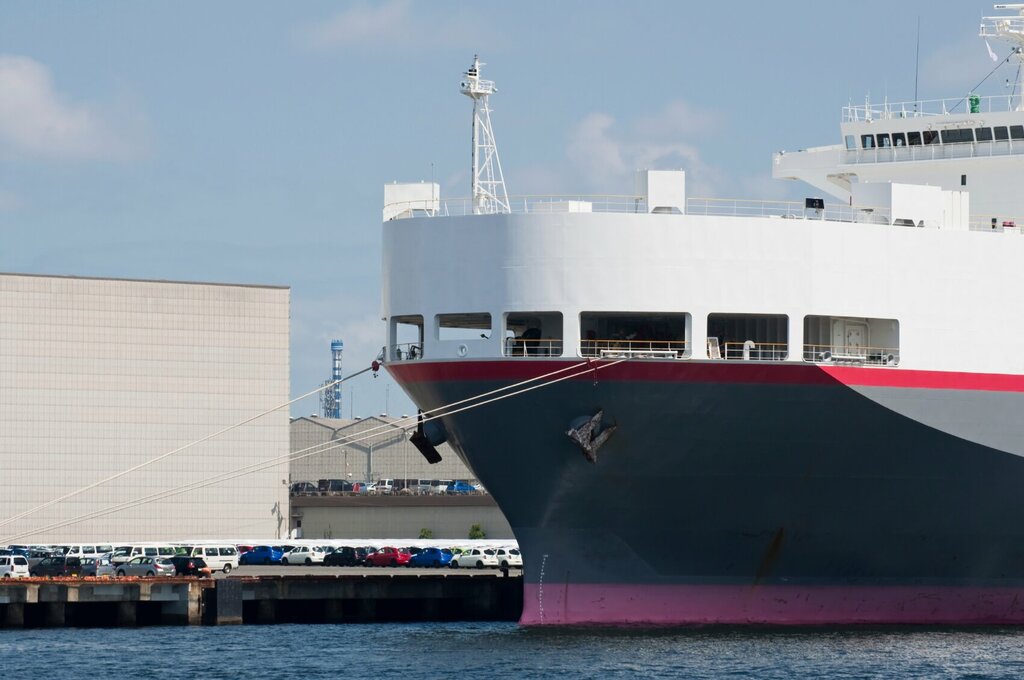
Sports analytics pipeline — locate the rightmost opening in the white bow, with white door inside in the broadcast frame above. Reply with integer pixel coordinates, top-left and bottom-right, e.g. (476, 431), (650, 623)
(804, 316), (899, 366)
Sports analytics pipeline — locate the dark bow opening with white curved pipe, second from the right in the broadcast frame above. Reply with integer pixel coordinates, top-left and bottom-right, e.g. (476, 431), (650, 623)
(708, 314), (790, 362)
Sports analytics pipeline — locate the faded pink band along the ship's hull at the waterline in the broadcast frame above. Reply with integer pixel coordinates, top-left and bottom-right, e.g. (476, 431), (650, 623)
(519, 583), (1024, 626)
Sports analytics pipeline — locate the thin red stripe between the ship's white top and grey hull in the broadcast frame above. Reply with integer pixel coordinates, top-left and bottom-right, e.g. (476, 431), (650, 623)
(387, 359), (1024, 392)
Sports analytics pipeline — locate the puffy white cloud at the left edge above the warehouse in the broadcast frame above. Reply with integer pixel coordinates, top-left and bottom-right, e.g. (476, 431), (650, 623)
(0, 55), (148, 159)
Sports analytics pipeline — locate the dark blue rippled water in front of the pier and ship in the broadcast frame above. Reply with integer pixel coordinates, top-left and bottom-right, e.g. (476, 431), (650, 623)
(0, 624), (1024, 680)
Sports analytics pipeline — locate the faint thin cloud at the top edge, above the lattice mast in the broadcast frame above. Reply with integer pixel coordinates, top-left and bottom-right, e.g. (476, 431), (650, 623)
(295, 0), (496, 52)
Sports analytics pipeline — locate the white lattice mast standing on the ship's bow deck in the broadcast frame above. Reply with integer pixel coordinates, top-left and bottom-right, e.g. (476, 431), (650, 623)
(461, 55), (511, 215)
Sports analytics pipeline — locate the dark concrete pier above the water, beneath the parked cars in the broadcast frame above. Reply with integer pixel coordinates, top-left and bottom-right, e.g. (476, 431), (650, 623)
(0, 571), (522, 628)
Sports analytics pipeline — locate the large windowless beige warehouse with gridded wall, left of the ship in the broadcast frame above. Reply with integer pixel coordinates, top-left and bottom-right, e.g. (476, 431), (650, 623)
(0, 273), (290, 544)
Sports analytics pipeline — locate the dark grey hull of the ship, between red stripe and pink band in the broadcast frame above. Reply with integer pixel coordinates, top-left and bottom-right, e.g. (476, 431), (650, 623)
(392, 362), (1024, 623)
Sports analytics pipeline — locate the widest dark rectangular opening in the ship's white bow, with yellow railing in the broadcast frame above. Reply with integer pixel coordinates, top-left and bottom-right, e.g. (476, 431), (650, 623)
(580, 311), (690, 358)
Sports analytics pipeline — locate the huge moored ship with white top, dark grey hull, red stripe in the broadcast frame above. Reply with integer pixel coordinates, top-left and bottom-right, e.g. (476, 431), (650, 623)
(382, 5), (1024, 625)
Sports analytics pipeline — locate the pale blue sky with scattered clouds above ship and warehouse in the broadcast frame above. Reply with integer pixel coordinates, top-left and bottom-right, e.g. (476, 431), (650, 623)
(0, 0), (1016, 417)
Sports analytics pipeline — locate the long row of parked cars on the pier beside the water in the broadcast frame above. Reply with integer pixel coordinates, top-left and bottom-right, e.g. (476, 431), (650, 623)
(0, 543), (522, 579)
